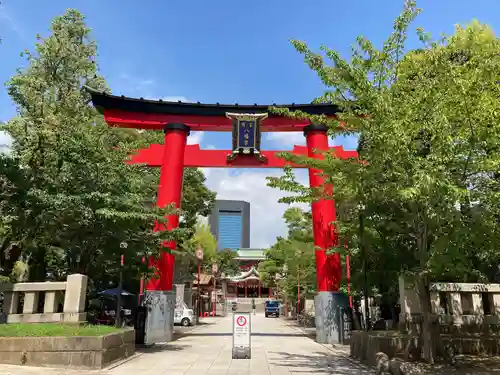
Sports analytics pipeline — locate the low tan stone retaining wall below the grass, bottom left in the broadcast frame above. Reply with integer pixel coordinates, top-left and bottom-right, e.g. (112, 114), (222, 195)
(0, 329), (135, 369)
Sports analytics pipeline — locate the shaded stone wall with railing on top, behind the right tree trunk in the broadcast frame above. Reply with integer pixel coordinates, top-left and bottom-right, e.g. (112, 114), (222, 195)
(350, 277), (500, 365)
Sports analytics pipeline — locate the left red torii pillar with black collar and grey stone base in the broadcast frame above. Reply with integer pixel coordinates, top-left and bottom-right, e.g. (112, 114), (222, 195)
(146, 123), (190, 343)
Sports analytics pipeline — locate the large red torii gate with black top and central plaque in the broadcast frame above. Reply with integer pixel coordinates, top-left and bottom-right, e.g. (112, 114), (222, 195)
(89, 89), (358, 342)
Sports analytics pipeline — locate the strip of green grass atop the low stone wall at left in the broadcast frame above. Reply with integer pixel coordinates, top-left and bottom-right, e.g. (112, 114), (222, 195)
(0, 323), (122, 337)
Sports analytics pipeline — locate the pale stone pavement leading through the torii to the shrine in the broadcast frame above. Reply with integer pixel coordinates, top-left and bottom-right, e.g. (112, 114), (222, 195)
(0, 314), (372, 375)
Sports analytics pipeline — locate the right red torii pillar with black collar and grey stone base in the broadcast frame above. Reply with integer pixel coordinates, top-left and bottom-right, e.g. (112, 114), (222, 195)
(304, 124), (349, 344)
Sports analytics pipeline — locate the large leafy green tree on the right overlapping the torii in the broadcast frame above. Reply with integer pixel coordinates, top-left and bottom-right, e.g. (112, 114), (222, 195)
(270, 0), (500, 362)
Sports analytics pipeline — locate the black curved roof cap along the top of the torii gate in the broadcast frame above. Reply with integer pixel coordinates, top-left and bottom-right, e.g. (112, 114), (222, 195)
(85, 87), (339, 117)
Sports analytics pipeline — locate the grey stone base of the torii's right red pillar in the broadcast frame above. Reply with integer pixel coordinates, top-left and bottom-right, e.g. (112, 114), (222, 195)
(314, 292), (349, 344)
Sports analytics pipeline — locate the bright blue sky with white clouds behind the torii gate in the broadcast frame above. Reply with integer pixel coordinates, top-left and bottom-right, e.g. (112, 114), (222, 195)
(0, 0), (500, 246)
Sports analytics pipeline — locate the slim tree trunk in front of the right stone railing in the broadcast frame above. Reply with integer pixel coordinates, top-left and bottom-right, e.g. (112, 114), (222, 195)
(417, 277), (439, 364)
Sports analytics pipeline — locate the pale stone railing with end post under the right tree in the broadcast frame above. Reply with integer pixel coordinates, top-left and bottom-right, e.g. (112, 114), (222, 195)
(399, 278), (500, 325)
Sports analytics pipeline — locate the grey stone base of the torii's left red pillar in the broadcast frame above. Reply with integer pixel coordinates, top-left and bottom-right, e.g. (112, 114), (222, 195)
(143, 290), (176, 345)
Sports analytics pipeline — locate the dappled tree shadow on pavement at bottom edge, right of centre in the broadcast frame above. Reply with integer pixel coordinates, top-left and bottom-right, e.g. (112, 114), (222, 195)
(268, 352), (373, 375)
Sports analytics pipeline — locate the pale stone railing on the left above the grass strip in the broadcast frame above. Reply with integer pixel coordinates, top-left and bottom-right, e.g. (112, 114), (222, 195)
(0, 274), (87, 323)
